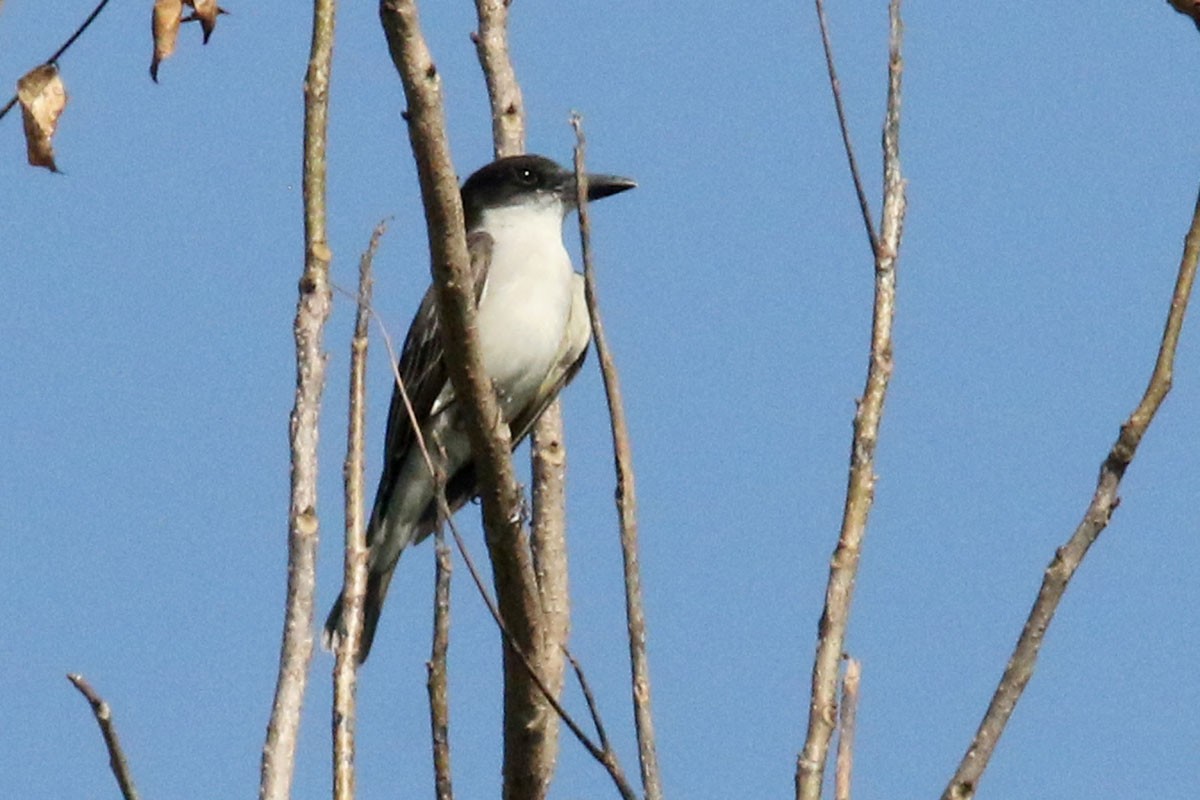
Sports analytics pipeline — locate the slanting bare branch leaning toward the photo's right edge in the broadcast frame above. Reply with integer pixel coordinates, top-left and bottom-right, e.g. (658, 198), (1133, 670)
(942, 179), (1200, 800)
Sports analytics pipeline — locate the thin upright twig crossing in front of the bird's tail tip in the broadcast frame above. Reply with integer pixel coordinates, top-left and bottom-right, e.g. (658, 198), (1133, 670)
(332, 222), (388, 800)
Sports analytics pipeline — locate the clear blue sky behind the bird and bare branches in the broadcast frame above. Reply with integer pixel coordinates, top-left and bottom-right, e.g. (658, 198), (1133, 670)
(0, 0), (1200, 799)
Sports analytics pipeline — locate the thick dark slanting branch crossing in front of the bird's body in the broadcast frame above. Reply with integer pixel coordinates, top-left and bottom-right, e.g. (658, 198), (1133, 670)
(379, 7), (544, 796)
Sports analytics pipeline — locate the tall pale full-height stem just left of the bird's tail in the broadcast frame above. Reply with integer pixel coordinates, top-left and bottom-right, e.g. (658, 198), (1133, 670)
(258, 0), (335, 800)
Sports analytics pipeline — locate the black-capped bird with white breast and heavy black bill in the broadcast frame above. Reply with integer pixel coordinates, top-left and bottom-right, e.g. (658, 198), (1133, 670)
(323, 155), (637, 663)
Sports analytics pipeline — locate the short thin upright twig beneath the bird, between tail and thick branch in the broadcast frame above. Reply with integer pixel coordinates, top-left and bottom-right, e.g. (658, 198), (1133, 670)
(427, 438), (454, 800)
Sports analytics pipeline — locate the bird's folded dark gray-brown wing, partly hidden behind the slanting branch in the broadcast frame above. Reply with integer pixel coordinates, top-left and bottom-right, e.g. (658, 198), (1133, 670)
(367, 231), (492, 546)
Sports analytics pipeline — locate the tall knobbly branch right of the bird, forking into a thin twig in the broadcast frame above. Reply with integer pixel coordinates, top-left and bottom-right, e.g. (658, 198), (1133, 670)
(796, 0), (905, 800)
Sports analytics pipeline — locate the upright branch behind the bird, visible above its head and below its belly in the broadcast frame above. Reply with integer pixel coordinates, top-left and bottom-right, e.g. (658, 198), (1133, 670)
(472, 0), (571, 798)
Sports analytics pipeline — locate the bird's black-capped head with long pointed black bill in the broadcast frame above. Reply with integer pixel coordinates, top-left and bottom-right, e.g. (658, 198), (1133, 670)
(462, 155), (637, 230)
